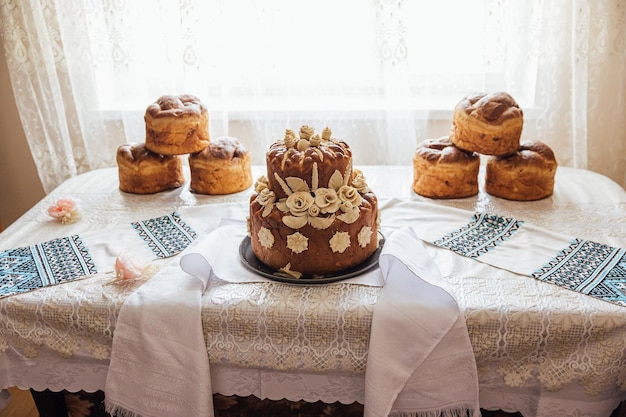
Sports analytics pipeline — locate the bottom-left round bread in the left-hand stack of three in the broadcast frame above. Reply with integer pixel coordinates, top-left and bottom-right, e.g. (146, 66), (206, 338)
(116, 144), (185, 194)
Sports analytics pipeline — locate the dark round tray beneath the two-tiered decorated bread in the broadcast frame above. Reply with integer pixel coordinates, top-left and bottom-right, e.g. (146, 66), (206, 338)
(239, 233), (385, 285)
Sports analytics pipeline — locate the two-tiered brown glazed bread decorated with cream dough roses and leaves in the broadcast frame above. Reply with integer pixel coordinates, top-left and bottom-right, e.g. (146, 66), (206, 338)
(248, 126), (378, 279)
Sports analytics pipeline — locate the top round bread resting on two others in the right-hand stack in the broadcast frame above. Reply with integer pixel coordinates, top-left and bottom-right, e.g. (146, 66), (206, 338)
(451, 92), (524, 155)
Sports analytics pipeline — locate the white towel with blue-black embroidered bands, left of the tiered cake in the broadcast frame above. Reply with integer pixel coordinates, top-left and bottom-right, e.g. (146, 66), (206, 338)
(0, 204), (246, 298)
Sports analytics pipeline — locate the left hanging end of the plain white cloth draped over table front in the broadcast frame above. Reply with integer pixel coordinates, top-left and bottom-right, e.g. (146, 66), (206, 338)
(105, 252), (213, 417)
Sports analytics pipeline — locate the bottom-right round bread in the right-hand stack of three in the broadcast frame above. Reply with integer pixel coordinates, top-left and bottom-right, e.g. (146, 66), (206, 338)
(485, 141), (558, 201)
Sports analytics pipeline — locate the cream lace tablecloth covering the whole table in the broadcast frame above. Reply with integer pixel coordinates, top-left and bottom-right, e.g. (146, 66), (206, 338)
(0, 166), (626, 417)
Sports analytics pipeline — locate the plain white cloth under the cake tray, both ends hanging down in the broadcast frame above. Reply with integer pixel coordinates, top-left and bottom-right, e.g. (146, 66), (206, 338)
(105, 219), (479, 417)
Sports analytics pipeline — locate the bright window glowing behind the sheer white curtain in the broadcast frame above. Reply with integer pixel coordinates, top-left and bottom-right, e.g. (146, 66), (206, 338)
(86, 0), (533, 117)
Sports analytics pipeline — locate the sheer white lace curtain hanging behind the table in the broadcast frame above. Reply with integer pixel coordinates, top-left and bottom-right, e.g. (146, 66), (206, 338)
(0, 0), (626, 191)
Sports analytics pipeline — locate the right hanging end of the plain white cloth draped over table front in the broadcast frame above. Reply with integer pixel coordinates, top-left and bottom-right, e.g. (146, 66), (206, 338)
(365, 228), (480, 417)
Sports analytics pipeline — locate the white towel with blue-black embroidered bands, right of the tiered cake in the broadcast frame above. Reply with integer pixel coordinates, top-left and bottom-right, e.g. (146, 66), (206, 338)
(384, 200), (626, 306)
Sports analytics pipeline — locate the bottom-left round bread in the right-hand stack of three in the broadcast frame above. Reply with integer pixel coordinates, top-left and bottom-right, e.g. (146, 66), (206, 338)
(413, 136), (480, 198)
